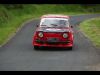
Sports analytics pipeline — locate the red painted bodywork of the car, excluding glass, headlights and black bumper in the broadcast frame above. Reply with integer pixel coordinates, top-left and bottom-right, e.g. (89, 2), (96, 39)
(33, 15), (74, 47)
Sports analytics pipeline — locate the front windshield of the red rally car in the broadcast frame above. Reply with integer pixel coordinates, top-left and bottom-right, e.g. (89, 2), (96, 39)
(40, 18), (69, 28)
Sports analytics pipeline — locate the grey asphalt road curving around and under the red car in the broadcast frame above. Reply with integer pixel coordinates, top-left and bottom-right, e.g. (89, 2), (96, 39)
(0, 14), (100, 71)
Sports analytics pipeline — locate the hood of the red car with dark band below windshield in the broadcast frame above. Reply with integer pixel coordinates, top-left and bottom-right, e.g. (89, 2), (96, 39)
(37, 28), (69, 33)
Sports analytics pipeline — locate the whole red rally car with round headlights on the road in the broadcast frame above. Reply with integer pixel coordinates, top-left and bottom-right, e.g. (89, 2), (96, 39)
(33, 14), (74, 50)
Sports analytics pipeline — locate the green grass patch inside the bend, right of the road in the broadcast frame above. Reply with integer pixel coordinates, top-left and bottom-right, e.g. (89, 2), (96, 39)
(79, 17), (100, 47)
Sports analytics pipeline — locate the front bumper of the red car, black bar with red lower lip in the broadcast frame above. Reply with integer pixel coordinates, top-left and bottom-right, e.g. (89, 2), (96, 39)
(33, 40), (73, 47)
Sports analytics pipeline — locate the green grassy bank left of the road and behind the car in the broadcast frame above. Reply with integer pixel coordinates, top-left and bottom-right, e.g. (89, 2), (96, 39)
(0, 4), (100, 46)
